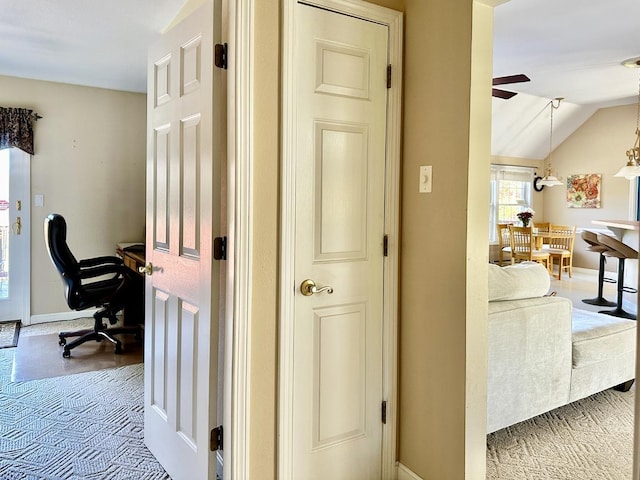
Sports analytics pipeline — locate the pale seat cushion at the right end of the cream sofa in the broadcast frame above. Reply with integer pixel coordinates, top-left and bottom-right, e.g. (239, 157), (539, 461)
(572, 309), (636, 368)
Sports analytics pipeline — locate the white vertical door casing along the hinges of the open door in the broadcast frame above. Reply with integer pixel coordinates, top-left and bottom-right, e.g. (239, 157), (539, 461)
(223, 0), (254, 480)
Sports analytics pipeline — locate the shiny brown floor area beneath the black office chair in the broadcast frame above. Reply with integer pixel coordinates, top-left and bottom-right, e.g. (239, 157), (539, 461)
(11, 333), (144, 382)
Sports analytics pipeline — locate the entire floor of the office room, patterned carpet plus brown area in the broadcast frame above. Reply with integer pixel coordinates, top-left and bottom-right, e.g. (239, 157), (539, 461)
(0, 318), (170, 480)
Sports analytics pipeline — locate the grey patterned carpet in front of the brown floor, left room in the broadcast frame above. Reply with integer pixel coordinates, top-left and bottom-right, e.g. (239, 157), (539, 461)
(0, 364), (171, 480)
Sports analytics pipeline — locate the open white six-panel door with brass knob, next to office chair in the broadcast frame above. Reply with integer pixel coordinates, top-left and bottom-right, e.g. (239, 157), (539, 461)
(144, 0), (224, 480)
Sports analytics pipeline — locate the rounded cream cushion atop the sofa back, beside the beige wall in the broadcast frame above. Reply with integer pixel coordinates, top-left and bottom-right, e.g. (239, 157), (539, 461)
(489, 262), (551, 302)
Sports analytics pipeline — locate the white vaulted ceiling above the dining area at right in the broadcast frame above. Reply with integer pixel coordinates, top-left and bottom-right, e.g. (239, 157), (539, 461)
(492, 0), (640, 159)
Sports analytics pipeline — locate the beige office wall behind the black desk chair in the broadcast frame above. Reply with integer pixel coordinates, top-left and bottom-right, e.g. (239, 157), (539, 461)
(0, 76), (146, 316)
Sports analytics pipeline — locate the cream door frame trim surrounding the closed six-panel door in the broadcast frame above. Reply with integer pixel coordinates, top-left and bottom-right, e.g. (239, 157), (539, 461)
(278, 0), (403, 480)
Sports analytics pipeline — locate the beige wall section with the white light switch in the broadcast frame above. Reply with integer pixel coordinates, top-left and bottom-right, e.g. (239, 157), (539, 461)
(399, 0), (491, 479)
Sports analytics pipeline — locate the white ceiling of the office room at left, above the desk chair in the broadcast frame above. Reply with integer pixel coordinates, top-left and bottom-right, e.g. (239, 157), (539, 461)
(0, 0), (185, 92)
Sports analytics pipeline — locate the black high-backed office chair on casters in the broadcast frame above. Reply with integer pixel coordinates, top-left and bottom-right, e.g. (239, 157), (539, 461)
(44, 213), (141, 357)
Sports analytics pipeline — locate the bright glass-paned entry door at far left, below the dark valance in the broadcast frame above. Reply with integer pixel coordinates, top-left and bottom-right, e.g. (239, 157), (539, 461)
(0, 148), (31, 325)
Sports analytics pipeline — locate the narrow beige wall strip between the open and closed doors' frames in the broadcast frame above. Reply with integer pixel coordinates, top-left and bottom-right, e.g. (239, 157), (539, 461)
(247, 0), (280, 474)
